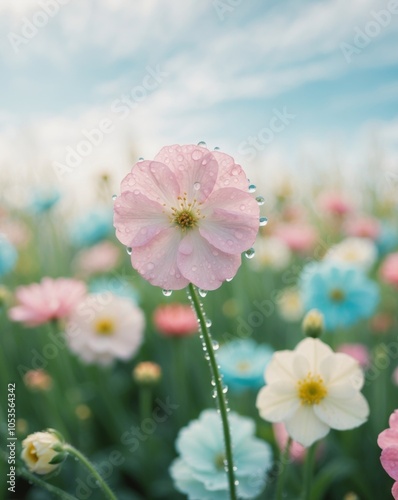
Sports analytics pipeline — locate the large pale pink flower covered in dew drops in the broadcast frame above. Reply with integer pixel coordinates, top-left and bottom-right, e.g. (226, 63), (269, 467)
(114, 145), (259, 290)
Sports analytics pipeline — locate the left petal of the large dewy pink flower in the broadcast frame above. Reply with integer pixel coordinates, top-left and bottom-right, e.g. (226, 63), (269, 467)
(114, 191), (170, 247)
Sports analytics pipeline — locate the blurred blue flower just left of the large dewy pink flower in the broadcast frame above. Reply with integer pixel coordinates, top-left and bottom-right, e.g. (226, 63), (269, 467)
(70, 208), (113, 247)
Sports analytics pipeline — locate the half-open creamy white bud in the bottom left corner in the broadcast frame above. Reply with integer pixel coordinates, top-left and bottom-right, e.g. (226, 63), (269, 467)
(21, 429), (66, 474)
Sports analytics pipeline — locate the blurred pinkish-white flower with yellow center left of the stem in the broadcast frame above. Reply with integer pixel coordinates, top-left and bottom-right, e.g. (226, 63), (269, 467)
(66, 292), (145, 365)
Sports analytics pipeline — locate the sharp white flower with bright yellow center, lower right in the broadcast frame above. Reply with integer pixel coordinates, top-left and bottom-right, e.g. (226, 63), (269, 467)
(256, 338), (369, 446)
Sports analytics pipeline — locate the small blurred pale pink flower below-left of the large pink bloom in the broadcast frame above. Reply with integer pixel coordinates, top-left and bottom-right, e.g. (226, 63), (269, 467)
(74, 241), (120, 276)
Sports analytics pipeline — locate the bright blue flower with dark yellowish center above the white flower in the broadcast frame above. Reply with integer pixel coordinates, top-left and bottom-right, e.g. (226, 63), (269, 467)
(300, 262), (380, 330)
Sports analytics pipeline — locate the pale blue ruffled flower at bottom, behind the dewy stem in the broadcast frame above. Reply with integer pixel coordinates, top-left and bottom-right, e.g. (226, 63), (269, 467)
(170, 410), (272, 500)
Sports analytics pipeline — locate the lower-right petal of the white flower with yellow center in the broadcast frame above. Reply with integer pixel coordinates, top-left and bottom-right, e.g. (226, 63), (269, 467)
(313, 391), (369, 431)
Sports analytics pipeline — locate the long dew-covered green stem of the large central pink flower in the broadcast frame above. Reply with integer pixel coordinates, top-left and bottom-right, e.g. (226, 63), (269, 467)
(188, 283), (237, 500)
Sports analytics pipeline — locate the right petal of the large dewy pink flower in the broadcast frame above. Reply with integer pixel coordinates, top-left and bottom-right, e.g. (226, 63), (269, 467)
(199, 188), (260, 254)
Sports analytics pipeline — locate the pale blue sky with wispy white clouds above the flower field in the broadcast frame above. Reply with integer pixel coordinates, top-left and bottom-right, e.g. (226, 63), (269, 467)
(0, 0), (398, 207)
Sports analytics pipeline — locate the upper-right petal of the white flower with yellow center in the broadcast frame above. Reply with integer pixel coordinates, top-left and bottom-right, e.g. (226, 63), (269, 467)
(319, 353), (364, 390)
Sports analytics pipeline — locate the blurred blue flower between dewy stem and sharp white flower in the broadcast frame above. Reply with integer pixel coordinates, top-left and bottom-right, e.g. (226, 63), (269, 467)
(217, 339), (274, 391)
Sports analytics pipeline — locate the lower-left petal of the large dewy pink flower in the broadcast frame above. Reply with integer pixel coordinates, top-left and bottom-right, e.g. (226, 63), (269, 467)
(131, 227), (189, 290)
